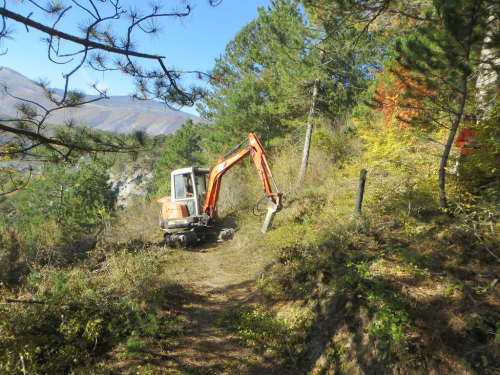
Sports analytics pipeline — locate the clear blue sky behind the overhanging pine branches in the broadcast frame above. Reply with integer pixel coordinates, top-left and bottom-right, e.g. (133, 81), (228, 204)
(0, 0), (270, 114)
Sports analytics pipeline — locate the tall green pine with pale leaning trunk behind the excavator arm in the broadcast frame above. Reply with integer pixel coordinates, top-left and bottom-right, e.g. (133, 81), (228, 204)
(200, 0), (370, 183)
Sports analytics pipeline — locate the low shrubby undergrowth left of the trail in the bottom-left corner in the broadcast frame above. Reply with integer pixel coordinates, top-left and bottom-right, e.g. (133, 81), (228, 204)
(0, 242), (186, 374)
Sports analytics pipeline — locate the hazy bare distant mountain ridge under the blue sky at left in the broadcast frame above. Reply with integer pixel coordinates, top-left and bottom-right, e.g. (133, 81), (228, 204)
(0, 67), (201, 135)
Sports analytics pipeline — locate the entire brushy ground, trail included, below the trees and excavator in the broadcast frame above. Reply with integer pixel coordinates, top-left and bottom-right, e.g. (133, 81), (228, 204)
(0, 134), (500, 375)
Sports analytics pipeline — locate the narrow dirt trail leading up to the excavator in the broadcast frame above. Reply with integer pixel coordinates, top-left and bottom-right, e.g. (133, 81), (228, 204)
(162, 242), (283, 374)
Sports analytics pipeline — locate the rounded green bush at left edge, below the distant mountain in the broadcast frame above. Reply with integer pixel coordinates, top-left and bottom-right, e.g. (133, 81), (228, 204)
(0, 162), (114, 274)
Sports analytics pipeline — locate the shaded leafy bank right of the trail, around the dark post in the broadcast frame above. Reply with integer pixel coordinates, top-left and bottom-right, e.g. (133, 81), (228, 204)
(222, 166), (500, 374)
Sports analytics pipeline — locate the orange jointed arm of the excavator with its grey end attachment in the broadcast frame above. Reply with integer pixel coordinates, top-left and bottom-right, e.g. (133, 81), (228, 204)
(203, 133), (282, 233)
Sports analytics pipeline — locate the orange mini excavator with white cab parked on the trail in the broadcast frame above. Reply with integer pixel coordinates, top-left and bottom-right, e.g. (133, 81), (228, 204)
(157, 133), (283, 246)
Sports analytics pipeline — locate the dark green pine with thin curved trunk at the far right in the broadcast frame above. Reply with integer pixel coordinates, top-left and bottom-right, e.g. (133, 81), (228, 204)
(396, 0), (496, 209)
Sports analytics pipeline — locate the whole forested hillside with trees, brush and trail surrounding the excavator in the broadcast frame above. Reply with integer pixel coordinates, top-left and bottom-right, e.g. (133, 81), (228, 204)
(0, 0), (500, 375)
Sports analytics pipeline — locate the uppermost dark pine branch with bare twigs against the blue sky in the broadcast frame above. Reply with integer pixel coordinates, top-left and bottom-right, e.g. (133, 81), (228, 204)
(0, 0), (220, 109)
